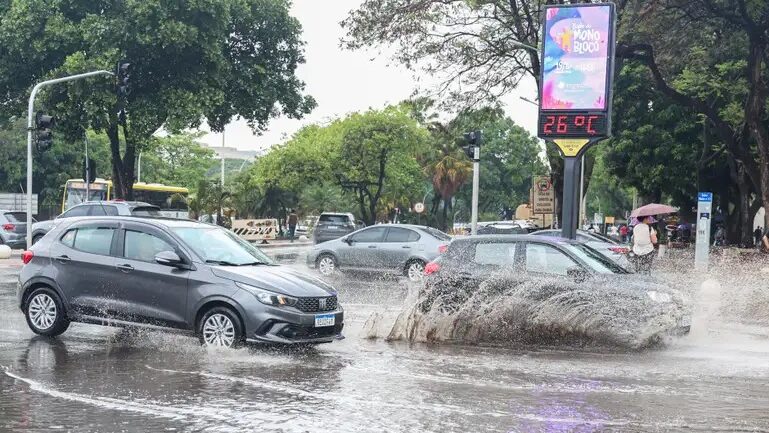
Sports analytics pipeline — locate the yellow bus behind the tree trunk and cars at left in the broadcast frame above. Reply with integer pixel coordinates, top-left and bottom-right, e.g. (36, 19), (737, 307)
(61, 178), (190, 218)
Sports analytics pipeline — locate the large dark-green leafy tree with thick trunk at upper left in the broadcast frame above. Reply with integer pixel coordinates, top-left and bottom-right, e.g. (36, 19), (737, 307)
(0, 0), (315, 199)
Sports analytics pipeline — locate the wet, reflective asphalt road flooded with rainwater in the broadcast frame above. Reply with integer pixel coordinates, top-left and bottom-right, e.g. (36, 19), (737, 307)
(0, 246), (769, 432)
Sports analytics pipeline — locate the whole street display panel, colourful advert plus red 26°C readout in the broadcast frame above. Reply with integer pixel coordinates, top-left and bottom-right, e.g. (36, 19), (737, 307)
(538, 3), (616, 140)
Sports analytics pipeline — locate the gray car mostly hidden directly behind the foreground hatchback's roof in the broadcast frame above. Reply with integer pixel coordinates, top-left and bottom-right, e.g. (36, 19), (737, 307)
(32, 200), (162, 245)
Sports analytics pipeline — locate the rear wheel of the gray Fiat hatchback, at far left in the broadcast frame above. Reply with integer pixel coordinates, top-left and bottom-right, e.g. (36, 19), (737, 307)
(24, 287), (69, 337)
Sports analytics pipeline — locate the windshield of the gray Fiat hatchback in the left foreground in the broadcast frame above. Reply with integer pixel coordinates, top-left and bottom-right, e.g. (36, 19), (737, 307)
(172, 227), (272, 266)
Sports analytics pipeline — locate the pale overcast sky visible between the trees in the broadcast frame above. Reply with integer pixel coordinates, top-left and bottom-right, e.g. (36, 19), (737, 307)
(195, 0), (537, 150)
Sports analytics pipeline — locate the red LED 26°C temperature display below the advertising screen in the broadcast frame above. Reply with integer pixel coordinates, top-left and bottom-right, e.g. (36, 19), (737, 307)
(539, 111), (608, 138)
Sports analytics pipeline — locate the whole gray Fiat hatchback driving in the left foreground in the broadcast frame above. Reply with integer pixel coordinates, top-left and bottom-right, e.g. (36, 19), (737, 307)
(17, 217), (344, 347)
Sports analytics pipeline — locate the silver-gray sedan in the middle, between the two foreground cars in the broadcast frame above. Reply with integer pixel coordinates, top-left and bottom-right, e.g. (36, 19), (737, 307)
(307, 224), (451, 281)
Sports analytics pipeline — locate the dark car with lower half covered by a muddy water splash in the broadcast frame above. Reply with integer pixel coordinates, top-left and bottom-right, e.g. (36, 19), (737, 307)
(419, 235), (691, 340)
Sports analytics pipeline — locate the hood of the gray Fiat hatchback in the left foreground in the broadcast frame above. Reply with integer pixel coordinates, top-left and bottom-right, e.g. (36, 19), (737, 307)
(211, 265), (336, 297)
